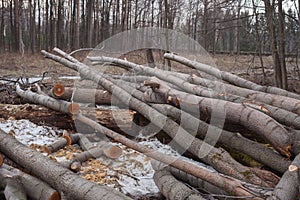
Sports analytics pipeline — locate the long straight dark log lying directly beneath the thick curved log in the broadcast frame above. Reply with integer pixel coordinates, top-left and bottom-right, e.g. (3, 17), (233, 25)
(112, 77), (290, 173)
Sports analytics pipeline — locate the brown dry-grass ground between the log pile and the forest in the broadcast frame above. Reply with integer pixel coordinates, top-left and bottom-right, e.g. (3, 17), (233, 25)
(0, 51), (300, 93)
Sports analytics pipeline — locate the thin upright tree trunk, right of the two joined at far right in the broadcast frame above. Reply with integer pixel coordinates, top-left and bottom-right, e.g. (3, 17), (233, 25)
(278, 0), (288, 90)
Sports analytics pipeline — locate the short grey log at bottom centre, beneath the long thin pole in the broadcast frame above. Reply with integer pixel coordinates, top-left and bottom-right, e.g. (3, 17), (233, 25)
(153, 169), (204, 200)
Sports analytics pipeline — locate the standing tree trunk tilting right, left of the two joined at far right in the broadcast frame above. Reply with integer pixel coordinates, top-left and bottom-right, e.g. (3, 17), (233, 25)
(264, 0), (283, 88)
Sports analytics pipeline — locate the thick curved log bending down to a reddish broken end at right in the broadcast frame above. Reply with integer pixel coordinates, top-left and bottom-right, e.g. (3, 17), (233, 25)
(146, 79), (293, 157)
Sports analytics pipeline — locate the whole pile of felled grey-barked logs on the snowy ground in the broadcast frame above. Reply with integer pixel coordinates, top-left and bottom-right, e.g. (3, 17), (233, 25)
(0, 48), (300, 200)
